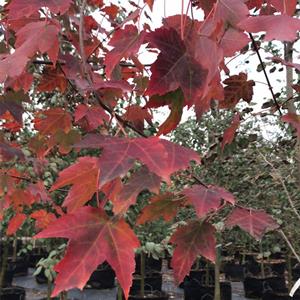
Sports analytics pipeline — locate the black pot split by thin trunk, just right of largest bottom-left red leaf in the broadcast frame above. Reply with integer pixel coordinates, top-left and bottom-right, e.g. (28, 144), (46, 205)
(130, 272), (162, 294)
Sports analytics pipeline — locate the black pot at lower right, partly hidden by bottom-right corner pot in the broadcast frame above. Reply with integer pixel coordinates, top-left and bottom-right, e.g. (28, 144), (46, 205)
(244, 276), (287, 298)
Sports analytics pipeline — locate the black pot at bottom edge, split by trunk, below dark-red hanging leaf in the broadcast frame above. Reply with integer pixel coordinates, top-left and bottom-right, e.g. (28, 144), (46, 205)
(184, 282), (232, 300)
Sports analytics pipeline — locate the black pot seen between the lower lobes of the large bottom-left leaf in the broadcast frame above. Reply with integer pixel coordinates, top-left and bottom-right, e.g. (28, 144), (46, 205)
(86, 263), (116, 289)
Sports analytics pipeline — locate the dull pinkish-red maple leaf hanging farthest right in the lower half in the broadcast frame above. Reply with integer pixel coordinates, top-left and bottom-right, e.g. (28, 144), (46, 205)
(226, 207), (279, 240)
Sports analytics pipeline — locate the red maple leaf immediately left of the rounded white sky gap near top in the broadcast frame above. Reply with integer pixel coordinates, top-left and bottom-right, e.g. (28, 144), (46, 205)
(104, 25), (145, 78)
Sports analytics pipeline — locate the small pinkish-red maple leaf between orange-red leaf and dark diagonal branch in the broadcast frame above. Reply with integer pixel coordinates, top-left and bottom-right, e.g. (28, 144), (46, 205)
(74, 104), (109, 131)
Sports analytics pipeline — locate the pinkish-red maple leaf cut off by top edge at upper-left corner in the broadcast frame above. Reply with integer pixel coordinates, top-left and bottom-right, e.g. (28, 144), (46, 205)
(7, 0), (73, 19)
